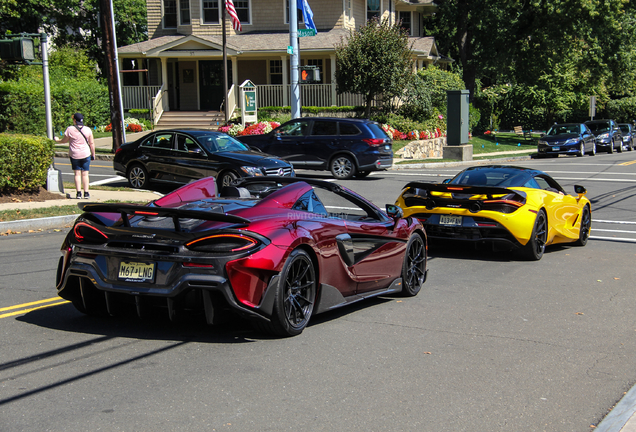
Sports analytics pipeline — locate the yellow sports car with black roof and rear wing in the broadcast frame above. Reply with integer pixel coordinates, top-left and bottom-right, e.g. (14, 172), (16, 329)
(396, 165), (592, 260)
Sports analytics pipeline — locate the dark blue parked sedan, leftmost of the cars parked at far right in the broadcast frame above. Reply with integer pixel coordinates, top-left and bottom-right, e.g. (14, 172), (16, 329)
(537, 123), (596, 156)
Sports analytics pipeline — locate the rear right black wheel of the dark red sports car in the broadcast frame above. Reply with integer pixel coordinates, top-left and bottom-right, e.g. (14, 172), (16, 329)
(256, 249), (318, 337)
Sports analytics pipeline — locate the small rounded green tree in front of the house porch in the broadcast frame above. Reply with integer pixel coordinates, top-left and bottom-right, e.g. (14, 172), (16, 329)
(336, 20), (413, 118)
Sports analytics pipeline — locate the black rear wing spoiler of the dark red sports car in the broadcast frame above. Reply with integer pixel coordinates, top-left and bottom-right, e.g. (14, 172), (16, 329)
(77, 203), (250, 231)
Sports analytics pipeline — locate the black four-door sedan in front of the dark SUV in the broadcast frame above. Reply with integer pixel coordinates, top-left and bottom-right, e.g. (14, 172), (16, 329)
(113, 129), (294, 189)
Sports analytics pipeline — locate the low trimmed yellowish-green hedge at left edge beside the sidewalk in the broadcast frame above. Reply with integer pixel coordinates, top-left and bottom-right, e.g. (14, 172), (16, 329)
(0, 133), (54, 191)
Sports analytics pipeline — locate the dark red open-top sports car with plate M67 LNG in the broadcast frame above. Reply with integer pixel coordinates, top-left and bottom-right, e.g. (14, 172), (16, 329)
(56, 177), (427, 336)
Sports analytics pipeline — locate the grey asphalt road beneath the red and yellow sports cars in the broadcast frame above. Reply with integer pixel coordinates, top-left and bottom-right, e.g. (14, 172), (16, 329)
(0, 152), (636, 432)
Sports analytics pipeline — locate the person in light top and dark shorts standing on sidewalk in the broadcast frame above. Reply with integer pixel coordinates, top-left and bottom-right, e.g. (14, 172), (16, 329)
(55, 113), (95, 199)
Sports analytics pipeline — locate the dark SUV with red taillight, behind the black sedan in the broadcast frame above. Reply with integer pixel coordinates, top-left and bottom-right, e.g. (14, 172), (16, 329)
(238, 117), (393, 180)
